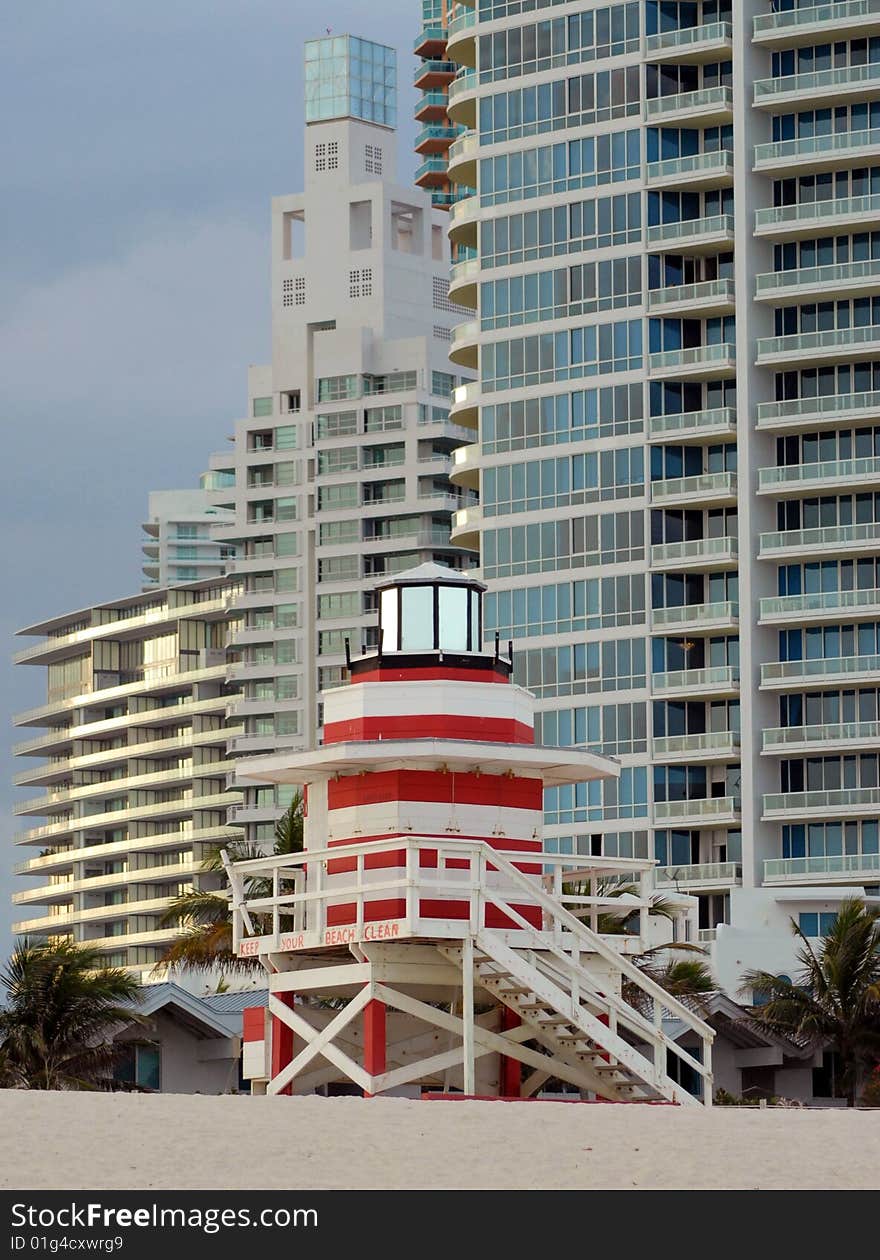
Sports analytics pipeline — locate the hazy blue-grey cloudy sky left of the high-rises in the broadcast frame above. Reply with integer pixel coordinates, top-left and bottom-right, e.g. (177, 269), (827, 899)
(0, 0), (421, 959)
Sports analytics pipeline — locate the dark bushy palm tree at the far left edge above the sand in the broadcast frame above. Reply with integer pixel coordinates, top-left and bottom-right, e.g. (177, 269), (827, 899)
(0, 940), (140, 1090)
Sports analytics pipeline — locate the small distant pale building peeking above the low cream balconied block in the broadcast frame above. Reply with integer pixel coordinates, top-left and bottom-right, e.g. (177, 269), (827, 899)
(141, 488), (236, 591)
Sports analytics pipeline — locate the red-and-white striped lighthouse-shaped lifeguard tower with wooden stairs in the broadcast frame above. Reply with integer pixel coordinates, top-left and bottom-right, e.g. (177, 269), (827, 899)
(227, 564), (712, 1106)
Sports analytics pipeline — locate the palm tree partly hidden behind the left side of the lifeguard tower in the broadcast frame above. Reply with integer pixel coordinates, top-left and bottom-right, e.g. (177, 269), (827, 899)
(156, 791), (304, 974)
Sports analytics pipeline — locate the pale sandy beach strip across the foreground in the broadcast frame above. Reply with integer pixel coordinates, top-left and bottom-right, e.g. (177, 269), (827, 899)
(0, 1091), (880, 1189)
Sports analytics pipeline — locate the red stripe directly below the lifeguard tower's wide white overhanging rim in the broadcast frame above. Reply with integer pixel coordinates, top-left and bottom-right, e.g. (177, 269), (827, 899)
(327, 770), (543, 811)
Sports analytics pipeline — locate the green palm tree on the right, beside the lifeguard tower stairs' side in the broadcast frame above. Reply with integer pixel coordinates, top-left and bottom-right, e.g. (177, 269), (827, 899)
(743, 897), (880, 1106)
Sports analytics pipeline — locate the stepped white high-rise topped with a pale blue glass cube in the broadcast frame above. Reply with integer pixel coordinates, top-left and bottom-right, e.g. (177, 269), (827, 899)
(201, 35), (475, 842)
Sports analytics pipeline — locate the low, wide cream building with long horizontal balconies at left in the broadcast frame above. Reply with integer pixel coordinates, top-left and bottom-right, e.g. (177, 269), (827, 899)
(13, 578), (241, 979)
